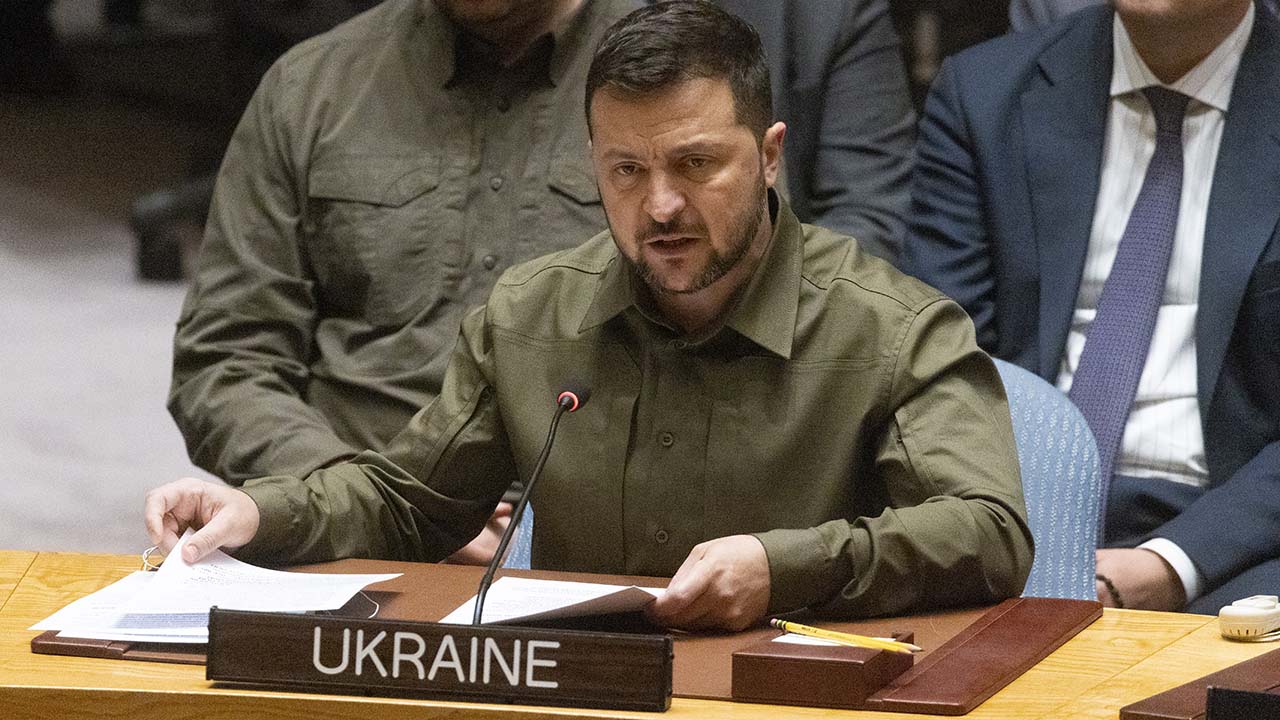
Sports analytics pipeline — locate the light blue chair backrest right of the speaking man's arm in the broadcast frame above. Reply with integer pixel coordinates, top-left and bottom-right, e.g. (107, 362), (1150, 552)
(996, 360), (1102, 600)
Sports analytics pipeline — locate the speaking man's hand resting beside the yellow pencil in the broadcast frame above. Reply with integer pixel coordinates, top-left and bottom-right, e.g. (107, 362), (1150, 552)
(645, 536), (769, 630)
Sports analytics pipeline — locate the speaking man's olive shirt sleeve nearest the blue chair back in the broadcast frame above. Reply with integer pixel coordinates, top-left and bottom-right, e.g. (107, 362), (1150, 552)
(758, 294), (1033, 616)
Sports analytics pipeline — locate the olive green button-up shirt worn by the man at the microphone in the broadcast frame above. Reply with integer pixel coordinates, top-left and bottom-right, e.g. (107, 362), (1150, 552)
(241, 193), (1032, 616)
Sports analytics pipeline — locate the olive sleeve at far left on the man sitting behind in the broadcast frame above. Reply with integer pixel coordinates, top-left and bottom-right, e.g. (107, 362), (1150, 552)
(169, 64), (360, 484)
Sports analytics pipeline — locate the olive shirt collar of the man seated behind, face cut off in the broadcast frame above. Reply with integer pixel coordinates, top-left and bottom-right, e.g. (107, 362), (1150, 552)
(419, 0), (599, 87)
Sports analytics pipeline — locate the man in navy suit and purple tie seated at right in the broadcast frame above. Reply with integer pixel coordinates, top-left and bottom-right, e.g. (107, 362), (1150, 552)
(904, 0), (1280, 612)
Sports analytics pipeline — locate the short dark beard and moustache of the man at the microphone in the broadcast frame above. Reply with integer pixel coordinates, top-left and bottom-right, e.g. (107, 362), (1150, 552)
(605, 169), (768, 295)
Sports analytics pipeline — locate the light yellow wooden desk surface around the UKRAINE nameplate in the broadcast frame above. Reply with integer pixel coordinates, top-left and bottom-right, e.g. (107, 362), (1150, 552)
(0, 551), (1275, 720)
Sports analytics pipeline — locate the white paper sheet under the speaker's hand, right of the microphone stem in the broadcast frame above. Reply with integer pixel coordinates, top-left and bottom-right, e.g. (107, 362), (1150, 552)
(440, 575), (666, 625)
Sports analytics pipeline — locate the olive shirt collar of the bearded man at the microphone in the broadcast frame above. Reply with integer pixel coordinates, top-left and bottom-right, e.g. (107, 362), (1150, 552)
(579, 190), (804, 359)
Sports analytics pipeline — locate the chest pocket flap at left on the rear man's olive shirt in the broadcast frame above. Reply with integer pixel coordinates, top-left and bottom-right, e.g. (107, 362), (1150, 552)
(307, 155), (440, 208)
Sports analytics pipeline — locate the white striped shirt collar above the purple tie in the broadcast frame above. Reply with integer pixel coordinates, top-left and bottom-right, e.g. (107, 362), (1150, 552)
(1111, 3), (1256, 113)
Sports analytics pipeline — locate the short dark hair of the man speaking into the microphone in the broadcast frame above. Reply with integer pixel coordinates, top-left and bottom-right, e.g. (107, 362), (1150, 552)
(586, 0), (773, 142)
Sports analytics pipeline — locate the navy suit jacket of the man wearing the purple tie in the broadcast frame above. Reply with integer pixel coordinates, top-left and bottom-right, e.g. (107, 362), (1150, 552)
(904, 6), (1280, 588)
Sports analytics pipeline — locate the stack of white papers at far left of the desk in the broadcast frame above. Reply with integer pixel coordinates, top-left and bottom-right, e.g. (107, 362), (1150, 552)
(31, 530), (401, 643)
